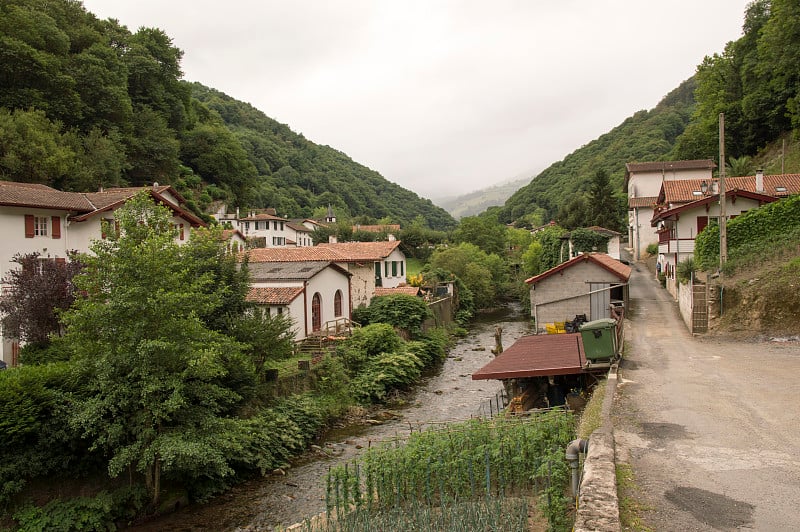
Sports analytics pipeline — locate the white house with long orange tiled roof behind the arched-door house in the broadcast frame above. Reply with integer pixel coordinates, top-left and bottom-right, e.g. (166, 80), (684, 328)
(247, 240), (406, 308)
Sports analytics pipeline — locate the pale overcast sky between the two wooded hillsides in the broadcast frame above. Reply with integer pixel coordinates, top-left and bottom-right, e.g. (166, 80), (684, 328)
(84, 0), (748, 199)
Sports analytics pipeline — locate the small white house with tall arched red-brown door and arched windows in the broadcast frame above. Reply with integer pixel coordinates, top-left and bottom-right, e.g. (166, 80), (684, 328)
(247, 261), (352, 340)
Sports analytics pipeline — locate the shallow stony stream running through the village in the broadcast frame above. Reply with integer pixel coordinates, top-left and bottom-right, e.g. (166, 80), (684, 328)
(132, 305), (532, 532)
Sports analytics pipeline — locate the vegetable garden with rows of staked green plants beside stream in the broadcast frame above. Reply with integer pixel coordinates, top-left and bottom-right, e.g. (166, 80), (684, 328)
(294, 410), (574, 532)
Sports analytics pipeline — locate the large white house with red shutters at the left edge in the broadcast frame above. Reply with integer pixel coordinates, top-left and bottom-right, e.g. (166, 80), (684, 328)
(0, 181), (205, 366)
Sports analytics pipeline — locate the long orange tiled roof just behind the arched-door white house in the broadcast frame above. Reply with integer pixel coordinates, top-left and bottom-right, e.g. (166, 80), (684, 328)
(248, 241), (400, 263)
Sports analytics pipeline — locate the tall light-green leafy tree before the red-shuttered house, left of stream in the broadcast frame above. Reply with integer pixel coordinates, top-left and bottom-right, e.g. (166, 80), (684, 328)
(65, 194), (247, 506)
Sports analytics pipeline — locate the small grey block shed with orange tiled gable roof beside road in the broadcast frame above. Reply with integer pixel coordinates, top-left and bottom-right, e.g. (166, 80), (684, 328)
(525, 253), (631, 333)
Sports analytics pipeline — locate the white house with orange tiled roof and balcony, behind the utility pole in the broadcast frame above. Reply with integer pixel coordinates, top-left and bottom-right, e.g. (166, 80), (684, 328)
(650, 172), (800, 296)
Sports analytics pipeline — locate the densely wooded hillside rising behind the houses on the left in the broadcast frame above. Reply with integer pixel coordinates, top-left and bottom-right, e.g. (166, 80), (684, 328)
(0, 0), (455, 229)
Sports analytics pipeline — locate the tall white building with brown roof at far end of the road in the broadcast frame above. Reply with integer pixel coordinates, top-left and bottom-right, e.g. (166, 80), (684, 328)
(625, 159), (716, 260)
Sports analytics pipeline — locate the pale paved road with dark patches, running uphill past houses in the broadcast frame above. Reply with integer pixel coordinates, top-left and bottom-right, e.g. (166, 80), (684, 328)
(615, 265), (800, 531)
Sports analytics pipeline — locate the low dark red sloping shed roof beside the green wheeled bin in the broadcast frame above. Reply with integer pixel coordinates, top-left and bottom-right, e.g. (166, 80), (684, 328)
(472, 333), (586, 380)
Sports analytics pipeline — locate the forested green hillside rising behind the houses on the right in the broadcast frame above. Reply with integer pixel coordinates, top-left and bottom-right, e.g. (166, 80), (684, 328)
(498, 0), (800, 232)
